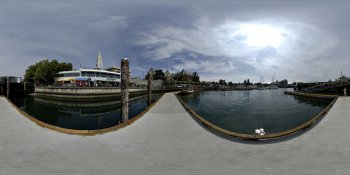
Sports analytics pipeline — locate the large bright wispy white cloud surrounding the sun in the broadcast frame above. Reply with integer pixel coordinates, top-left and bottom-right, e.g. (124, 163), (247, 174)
(135, 19), (336, 81)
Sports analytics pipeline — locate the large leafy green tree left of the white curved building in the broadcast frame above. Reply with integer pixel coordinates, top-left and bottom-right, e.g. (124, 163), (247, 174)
(24, 60), (73, 84)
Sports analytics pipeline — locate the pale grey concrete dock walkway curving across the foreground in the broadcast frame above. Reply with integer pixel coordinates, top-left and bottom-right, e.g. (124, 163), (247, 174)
(0, 93), (350, 175)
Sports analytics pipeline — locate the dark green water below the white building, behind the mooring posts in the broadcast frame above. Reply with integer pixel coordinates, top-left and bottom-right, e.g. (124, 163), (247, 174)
(12, 94), (161, 130)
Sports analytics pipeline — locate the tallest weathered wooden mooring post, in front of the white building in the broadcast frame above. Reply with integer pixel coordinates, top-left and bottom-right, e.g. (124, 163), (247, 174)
(120, 58), (130, 122)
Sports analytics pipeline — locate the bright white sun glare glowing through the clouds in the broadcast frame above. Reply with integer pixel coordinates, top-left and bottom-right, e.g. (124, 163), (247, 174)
(234, 24), (283, 48)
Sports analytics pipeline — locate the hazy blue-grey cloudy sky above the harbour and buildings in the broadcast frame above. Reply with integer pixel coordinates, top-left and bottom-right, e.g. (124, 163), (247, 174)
(0, 0), (350, 82)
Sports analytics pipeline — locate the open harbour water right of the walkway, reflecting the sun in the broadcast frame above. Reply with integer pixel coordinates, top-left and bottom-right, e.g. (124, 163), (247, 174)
(181, 89), (332, 134)
